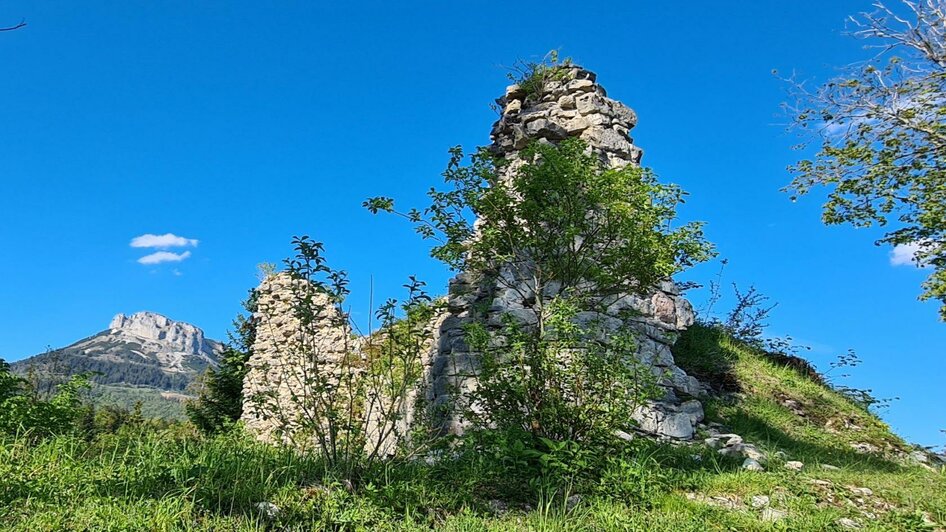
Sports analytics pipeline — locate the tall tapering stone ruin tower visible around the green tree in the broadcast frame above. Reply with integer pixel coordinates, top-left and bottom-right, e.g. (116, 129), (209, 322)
(427, 64), (704, 439)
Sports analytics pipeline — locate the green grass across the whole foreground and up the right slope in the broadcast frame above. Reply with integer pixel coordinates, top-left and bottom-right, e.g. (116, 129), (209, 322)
(0, 327), (946, 531)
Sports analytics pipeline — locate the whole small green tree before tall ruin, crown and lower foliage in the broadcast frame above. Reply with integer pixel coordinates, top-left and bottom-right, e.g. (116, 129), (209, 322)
(365, 139), (712, 438)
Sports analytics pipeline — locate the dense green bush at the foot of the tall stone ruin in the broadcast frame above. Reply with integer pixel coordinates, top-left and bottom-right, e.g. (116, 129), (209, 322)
(467, 298), (657, 442)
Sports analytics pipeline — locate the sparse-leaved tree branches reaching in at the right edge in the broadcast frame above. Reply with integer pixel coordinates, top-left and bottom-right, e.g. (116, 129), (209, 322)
(786, 0), (946, 319)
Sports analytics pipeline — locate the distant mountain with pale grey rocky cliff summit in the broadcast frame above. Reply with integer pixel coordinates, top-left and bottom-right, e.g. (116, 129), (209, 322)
(11, 312), (223, 417)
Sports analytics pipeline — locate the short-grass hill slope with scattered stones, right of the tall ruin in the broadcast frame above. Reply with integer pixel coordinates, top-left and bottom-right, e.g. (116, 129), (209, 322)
(671, 326), (946, 530)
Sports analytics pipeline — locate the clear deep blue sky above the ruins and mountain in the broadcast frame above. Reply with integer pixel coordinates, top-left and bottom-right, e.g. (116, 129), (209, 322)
(0, 0), (946, 445)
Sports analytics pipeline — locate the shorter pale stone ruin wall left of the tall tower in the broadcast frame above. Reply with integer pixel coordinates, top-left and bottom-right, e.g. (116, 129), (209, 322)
(241, 272), (444, 455)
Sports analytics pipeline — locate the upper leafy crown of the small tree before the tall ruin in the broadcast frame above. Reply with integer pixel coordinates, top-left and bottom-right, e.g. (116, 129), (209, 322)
(364, 138), (713, 334)
